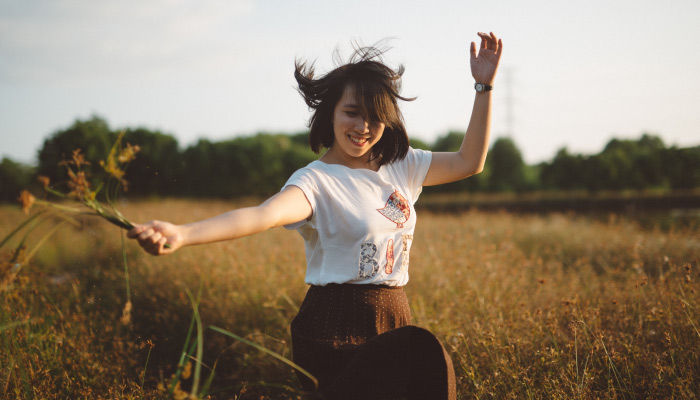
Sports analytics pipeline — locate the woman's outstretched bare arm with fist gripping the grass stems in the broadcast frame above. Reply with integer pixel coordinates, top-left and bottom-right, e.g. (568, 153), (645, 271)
(128, 186), (313, 255)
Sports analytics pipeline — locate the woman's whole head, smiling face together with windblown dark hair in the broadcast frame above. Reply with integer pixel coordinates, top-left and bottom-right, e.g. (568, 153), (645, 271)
(294, 43), (414, 168)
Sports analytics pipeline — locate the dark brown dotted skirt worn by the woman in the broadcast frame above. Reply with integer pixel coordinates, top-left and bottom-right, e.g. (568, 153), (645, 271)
(291, 284), (455, 400)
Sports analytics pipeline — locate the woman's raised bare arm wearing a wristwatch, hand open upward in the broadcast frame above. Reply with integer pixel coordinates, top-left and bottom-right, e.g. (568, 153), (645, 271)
(423, 32), (503, 186)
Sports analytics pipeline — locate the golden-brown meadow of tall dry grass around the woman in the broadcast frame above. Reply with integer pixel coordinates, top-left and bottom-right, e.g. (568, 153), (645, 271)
(0, 200), (700, 399)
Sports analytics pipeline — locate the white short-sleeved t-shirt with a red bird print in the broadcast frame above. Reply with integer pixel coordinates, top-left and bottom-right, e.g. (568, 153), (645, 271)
(284, 148), (432, 286)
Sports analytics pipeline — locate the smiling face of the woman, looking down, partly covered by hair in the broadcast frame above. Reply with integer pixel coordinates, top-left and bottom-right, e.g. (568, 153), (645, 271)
(329, 86), (385, 163)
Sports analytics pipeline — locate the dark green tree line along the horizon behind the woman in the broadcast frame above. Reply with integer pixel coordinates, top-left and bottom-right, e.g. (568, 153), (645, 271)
(0, 116), (700, 202)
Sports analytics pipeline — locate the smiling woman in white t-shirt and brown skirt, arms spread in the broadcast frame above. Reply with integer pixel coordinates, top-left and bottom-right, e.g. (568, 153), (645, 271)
(129, 33), (503, 399)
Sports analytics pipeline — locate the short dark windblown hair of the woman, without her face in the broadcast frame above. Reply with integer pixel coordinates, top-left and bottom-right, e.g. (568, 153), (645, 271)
(294, 45), (415, 165)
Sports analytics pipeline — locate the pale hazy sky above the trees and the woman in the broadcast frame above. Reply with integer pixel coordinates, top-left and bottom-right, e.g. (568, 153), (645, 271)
(0, 0), (700, 164)
